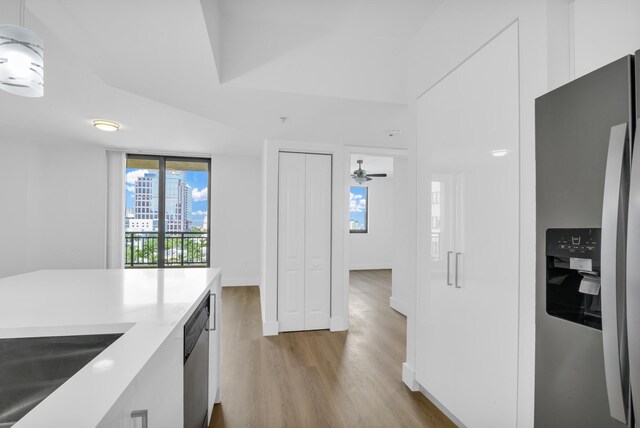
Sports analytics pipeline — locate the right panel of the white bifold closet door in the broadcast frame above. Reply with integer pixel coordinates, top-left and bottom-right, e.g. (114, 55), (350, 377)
(304, 154), (331, 330)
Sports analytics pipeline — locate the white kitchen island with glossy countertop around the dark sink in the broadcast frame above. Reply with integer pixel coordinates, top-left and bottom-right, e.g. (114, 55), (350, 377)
(0, 268), (221, 428)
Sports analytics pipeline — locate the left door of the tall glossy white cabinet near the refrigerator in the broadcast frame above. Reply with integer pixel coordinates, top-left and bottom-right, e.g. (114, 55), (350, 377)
(416, 61), (462, 412)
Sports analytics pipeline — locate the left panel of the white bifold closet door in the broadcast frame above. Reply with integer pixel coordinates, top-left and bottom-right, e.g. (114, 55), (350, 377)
(278, 153), (306, 331)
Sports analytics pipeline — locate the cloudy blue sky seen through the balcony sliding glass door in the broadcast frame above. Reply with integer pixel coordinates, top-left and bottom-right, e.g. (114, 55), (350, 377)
(125, 168), (209, 227)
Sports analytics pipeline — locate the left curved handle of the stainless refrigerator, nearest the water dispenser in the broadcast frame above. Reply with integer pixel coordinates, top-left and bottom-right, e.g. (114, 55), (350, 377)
(600, 123), (637, 423)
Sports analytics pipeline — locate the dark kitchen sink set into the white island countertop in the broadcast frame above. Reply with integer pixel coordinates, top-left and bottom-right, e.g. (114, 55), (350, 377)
(0, 334), (122, 428)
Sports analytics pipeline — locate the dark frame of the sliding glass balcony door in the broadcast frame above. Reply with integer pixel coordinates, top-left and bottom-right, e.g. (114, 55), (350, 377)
(123, 153), (211, 269)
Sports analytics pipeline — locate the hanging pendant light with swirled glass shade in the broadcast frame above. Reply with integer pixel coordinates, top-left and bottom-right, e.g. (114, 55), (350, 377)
(0, 0), (44, 97)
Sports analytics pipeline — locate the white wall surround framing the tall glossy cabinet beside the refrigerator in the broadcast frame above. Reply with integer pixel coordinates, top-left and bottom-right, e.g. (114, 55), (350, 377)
(403, 0), (547, 427)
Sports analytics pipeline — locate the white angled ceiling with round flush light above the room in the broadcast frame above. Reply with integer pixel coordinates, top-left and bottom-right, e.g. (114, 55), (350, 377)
(0, 0), (442, 154)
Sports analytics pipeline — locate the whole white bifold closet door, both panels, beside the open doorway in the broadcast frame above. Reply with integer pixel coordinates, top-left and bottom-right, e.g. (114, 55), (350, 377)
(278, 152), (331, 331)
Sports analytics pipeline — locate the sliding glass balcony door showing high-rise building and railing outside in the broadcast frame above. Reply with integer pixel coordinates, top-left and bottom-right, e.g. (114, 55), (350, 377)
(125, 155), (211, 268)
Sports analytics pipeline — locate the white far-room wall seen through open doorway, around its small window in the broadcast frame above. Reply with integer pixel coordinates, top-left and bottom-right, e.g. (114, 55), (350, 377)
(347, 175), (394, 270)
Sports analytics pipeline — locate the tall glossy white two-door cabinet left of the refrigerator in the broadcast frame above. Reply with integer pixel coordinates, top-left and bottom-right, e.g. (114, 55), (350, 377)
(416, 25), (519, 428)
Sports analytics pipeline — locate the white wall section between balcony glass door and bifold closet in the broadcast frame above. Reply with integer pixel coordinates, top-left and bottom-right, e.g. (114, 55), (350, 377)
(210, 156), (262, 286)
